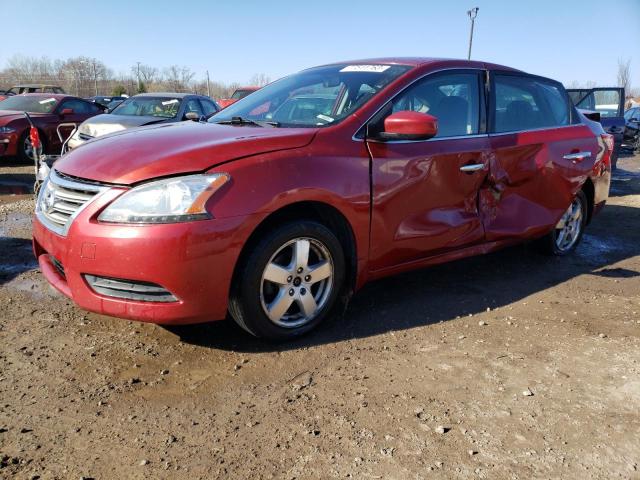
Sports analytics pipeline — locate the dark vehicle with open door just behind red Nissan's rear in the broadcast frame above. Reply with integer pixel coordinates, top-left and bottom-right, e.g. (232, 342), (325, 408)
(567, 87), (625, 169)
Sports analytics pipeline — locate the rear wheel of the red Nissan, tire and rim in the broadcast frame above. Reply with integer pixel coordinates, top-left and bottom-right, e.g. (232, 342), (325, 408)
(538, 190), (588, 257)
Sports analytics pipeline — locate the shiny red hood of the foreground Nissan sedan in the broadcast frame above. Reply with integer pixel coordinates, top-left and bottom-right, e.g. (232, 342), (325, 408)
(54, 122), (317, 185)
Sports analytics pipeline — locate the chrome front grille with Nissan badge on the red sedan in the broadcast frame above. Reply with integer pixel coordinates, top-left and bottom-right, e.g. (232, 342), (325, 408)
(36, 170), (107, 235)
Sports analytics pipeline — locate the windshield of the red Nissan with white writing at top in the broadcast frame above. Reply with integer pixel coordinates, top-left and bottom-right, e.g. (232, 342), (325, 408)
(209, 64), (411, 127)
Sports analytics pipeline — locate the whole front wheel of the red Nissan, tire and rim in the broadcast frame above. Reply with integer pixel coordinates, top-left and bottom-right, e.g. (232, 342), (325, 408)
(229, 221), (345, 340)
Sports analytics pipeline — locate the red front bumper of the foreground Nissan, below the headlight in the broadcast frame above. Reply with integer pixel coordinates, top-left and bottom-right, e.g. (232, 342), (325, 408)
(33, 195), (253, 325)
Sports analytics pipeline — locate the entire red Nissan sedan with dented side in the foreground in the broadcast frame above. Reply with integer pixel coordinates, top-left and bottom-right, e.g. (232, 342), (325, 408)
(33, 58), (611, 339)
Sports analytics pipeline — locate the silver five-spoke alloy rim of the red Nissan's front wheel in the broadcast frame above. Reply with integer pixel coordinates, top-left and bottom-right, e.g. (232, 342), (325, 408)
(260, 237), (334, 328)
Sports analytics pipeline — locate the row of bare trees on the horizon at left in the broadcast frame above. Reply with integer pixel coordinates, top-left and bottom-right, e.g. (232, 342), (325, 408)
(0, 55), (270, 98)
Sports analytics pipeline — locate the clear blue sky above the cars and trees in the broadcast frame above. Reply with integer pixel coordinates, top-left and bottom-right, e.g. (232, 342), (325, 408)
(0, 0), (640, 87)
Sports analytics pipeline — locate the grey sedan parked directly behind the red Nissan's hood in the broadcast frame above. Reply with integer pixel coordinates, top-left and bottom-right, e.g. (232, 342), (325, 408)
(69, 93), (220, 149)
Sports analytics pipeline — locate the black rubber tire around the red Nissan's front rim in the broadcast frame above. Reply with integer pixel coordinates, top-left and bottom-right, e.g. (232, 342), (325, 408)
(229, 220), (345, 340)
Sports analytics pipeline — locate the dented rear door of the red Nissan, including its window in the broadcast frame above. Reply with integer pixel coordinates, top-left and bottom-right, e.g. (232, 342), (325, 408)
(481, 71), (598, 241)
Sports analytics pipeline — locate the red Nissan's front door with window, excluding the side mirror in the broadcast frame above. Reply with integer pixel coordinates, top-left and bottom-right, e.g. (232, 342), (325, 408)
(366, 70), (491, 271)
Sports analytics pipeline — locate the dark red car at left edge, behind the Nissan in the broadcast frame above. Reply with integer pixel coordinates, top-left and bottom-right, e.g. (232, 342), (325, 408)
(0, 93), (104, 161)
